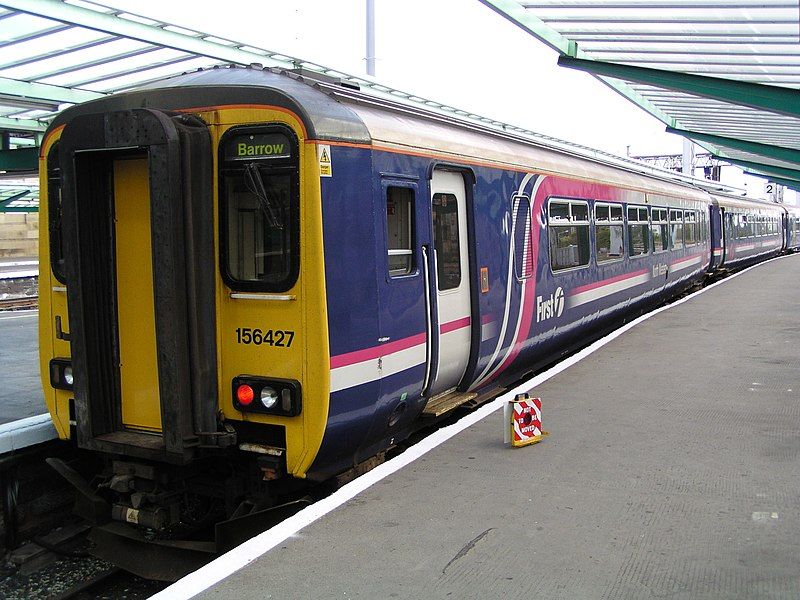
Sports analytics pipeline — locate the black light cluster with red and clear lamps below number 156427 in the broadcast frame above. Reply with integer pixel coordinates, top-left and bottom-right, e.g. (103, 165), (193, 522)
(232, 375), (302, 417)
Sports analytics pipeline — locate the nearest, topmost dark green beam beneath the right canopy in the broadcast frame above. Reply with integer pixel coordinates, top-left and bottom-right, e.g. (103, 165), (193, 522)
(558, 55), (800, 117)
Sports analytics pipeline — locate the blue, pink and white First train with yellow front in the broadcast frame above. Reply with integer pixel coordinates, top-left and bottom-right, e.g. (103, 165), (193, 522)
(39, 66), (800, 579)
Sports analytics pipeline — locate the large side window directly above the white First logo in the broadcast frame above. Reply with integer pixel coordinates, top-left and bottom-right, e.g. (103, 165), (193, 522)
(548, 200), (590, 271)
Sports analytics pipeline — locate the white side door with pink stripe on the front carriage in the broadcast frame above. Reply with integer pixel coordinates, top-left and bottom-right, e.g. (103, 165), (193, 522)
(429, 170), (472, 396)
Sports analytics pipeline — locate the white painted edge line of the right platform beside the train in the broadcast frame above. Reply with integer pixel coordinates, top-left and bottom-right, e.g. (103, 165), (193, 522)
(151, 255), (789, 600)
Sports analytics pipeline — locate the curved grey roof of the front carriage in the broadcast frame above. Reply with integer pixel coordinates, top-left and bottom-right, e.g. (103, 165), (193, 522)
(51, 66), (736, 201)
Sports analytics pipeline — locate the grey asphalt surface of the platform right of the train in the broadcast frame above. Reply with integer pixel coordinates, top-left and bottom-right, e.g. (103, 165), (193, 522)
(199, 256), (800, 600)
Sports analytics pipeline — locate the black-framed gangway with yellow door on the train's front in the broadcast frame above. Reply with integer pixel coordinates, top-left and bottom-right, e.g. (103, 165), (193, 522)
(59, 109), (219, 463)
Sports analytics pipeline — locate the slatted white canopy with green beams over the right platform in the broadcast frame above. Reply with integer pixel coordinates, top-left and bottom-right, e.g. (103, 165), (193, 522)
(481, 0), (800, 190)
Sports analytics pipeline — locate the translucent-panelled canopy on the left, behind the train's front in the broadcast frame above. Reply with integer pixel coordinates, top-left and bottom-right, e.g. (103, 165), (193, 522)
(0, 0), (394, 176)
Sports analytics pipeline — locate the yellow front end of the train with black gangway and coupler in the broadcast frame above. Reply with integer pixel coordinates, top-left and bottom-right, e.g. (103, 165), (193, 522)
(40, 69), (346, 579)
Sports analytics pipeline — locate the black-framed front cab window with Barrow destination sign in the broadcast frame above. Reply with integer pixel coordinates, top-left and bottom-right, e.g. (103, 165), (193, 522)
(220, 127), (300, 292)
